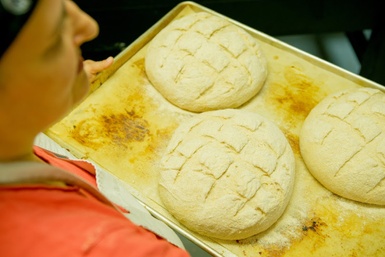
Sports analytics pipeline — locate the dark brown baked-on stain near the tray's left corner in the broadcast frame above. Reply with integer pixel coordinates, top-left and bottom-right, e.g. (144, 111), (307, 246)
(71, 110), (150, 150)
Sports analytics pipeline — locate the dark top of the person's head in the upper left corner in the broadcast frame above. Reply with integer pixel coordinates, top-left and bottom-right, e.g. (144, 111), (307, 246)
(0, 0), (38, 58)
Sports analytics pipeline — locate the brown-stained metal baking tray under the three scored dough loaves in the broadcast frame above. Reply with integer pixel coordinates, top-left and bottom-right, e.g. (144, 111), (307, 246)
(46, 2), (385, 254)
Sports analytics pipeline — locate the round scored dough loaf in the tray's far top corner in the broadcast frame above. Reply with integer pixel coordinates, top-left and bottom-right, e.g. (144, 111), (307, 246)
(145, 12), (267, 112)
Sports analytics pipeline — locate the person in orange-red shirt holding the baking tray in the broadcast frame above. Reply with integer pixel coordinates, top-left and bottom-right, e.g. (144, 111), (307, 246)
(0, 0), (189, 257)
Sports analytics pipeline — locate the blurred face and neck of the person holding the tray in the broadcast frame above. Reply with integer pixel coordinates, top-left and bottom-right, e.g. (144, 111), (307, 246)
(0, 0), (98, 133)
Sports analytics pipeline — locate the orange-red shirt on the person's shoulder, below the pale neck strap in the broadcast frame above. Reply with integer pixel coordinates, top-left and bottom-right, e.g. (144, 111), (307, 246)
(0, 184), (187, 257)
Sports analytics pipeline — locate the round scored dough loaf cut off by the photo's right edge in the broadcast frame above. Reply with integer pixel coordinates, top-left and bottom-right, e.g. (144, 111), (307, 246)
(300, 88), (385, 205)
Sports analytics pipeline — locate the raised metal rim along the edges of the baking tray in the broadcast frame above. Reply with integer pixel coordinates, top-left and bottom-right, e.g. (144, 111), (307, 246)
(72, 1), (385, 254)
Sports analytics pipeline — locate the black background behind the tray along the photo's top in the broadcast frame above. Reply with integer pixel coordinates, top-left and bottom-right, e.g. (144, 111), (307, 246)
(75, 0), (385, 85)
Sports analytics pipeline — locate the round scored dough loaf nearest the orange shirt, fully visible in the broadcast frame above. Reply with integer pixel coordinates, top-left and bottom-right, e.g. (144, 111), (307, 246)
(159, 109), (295, 240)
